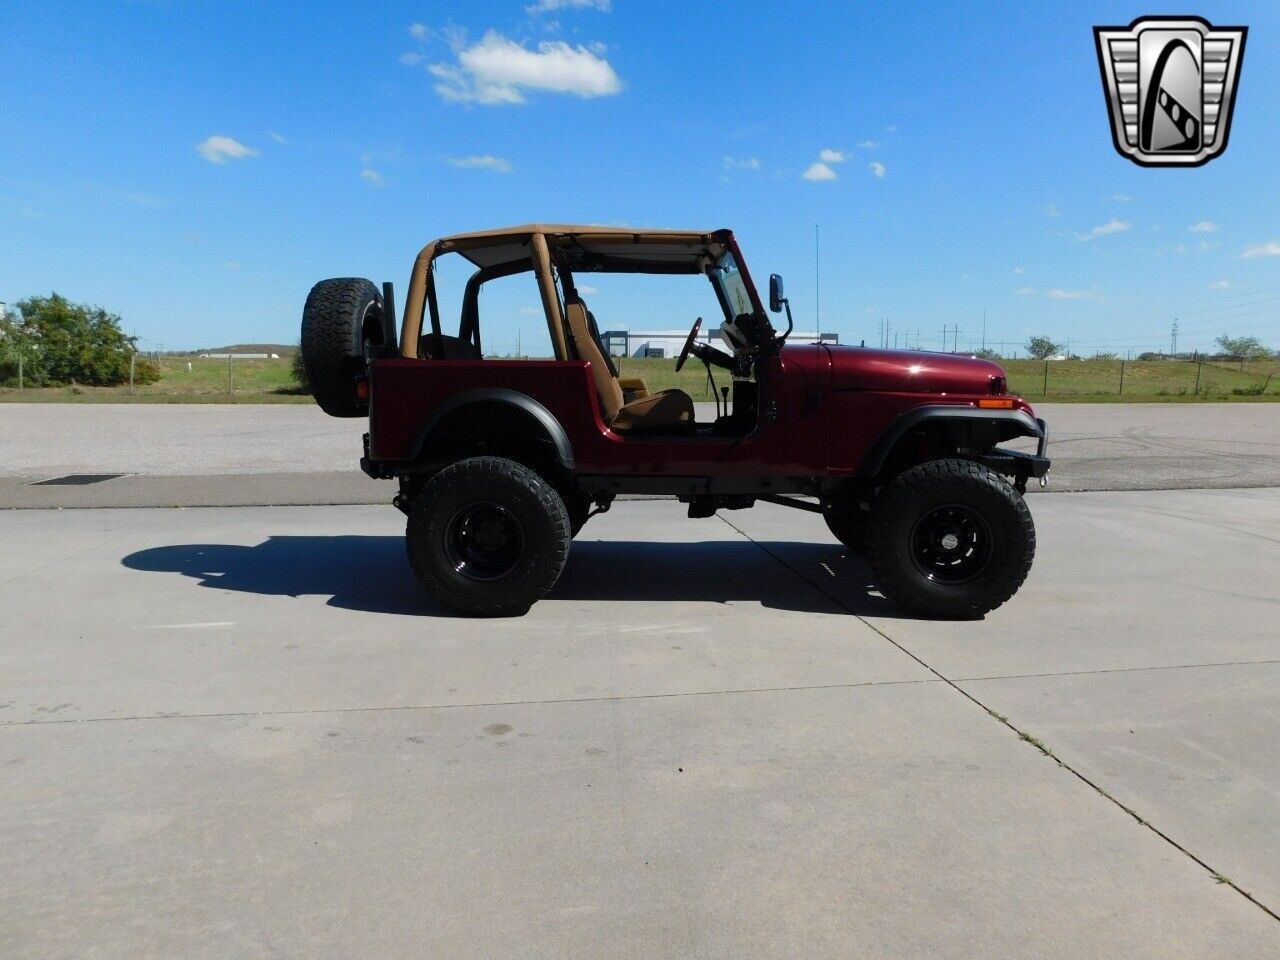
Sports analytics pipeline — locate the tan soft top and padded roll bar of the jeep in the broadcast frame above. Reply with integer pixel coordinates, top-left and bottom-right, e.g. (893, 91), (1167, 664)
(401, 224), (732, 360)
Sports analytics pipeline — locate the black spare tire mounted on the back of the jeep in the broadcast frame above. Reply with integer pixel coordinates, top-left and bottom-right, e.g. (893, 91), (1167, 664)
(302, 276), (383, 417)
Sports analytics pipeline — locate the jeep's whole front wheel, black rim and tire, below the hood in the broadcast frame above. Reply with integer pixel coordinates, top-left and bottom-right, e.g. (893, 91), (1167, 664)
(867, 460), (1036, 618)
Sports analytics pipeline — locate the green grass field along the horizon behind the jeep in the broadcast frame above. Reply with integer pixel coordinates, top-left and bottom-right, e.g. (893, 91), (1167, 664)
(0, 356), (1280, 403)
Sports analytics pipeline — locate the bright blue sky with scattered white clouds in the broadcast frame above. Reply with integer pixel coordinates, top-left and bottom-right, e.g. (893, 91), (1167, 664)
(0, 0), (1280, 353)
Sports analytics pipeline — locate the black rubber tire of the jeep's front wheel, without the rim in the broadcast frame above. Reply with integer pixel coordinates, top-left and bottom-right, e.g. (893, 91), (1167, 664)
(867, 458), (1036, 617)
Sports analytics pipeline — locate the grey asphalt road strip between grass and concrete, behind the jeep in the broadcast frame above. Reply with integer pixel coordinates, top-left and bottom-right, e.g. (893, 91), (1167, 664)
(0, 403), (1280, 507)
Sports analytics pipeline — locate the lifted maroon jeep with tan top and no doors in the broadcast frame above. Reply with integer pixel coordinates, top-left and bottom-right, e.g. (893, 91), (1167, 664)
(302, 224), (1050, 617)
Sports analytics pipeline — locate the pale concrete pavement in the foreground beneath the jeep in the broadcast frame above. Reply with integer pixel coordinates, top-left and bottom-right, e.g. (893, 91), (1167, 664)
(0, 491), (1280, 960)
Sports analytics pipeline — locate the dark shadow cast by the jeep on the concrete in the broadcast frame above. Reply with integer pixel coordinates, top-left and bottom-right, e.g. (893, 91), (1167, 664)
(122, 536), (906, 617)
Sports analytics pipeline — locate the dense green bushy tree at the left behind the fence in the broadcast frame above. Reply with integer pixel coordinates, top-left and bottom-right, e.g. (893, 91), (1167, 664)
(0, 293), (160, 387)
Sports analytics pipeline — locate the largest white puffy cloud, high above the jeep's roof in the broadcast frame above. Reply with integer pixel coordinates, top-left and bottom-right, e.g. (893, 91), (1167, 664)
(428, 31), (622, 106)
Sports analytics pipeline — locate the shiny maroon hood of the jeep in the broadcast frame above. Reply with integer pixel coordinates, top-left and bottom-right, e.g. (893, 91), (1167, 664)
(824, 344), (1007, 393)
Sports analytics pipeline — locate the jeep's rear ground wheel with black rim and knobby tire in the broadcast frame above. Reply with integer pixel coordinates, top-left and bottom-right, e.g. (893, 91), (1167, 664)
(404, 457), (571, 617)
